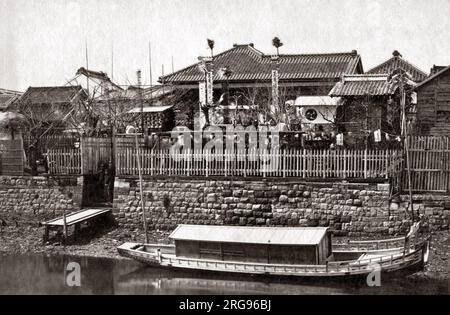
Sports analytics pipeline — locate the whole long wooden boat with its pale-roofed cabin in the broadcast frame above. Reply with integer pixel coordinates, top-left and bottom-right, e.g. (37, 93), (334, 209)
(118, 224), (429, 278)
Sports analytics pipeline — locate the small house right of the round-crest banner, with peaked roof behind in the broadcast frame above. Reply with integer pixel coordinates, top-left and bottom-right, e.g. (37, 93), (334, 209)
(329, 50), (427, 147)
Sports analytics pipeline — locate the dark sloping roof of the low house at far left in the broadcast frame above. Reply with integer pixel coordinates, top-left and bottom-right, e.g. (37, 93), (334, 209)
(20, 85), (84, 104)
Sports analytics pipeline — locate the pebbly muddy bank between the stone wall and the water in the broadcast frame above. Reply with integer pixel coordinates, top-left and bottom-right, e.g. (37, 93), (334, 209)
(0, 224), (450, 280)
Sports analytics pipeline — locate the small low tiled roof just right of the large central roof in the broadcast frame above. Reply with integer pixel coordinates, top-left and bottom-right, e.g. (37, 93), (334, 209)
(328, 74), (394, 96)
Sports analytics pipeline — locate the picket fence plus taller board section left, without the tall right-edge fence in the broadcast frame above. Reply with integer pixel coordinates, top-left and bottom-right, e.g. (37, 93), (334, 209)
(47, 138), (403, 179)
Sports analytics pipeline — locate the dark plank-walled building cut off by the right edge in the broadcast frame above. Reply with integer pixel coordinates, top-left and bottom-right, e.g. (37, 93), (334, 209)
(415, 66), (450, 136)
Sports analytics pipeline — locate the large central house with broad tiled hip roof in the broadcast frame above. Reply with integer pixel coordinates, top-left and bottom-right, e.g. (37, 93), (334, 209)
(159, 44), (363, 130)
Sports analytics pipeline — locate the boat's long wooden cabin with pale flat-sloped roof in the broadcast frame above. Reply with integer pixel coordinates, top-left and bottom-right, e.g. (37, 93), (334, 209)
(170, 224), (331, 265)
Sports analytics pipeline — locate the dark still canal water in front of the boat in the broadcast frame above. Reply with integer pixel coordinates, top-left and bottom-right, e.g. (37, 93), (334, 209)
(0, 255), (450, 295)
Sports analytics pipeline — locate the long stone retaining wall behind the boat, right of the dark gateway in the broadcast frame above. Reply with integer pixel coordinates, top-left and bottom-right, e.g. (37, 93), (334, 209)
(114, 178), (440, 236)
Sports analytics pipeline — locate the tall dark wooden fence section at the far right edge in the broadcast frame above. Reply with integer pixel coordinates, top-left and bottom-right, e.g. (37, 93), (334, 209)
(404, 136), (450, 193)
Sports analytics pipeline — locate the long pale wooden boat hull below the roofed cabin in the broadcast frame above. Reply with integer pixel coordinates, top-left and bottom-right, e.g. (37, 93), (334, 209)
(118, 241), (428, 279)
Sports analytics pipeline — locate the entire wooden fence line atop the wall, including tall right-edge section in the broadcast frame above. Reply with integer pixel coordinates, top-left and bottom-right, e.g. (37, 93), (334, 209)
(43, 136), (450, 193)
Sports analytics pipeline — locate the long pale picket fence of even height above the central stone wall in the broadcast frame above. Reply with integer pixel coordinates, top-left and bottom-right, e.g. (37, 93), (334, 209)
(116, 147), (402, 179)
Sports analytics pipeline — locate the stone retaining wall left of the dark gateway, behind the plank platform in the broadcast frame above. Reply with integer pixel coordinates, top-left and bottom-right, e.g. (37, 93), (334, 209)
(0, 176), (83, 221)
